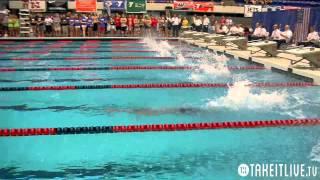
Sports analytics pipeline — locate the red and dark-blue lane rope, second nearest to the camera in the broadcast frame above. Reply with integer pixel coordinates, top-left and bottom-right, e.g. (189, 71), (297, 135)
(0, 82), (318, 91)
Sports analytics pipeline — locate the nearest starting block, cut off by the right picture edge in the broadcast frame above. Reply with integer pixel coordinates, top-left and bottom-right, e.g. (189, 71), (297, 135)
(285, 47), (320, 68)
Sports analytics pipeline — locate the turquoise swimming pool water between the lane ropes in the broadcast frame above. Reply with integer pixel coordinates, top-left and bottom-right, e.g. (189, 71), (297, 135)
(0, 41), (320, 179)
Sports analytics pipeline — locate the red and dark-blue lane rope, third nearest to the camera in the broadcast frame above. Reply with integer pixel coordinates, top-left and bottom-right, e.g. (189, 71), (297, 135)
(0, 66), (265, 72)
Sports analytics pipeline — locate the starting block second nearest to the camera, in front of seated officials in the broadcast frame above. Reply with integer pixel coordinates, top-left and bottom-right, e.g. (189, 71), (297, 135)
(248, 40), (279, 57)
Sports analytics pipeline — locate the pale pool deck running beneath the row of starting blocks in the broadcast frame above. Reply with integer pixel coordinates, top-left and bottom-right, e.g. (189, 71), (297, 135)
(180, 38), (320, 85)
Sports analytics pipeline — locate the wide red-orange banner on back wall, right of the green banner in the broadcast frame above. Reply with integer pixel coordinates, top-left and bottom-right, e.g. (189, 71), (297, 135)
(173, 1), (214, 12)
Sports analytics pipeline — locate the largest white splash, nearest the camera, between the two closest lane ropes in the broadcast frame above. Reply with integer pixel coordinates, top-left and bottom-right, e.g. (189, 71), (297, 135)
(206, 81), (288, 110)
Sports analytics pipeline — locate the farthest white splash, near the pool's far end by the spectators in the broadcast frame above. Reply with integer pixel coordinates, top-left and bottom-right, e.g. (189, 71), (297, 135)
(143, 38), (173, 57)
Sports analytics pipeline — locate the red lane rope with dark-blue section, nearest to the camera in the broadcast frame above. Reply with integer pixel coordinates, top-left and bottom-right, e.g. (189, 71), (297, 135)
(0, 118), (320, 137)
